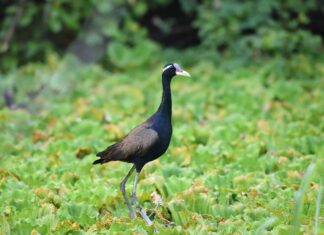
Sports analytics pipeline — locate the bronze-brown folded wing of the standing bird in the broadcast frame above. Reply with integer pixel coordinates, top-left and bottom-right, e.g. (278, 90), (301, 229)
(94, 122), (159, 164)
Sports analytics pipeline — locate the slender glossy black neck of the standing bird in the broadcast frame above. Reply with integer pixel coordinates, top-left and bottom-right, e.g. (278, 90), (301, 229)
(157, 77), (172, 120)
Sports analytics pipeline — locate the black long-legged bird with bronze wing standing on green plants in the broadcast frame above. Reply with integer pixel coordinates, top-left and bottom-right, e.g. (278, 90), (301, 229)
(93, 63), (190, 225)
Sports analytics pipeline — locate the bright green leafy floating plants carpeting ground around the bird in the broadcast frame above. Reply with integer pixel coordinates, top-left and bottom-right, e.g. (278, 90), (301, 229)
(0, 54), (324, 234)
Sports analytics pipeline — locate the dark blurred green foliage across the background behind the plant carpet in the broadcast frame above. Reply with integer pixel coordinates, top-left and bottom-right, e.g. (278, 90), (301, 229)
(0, 0), (323, 69)
